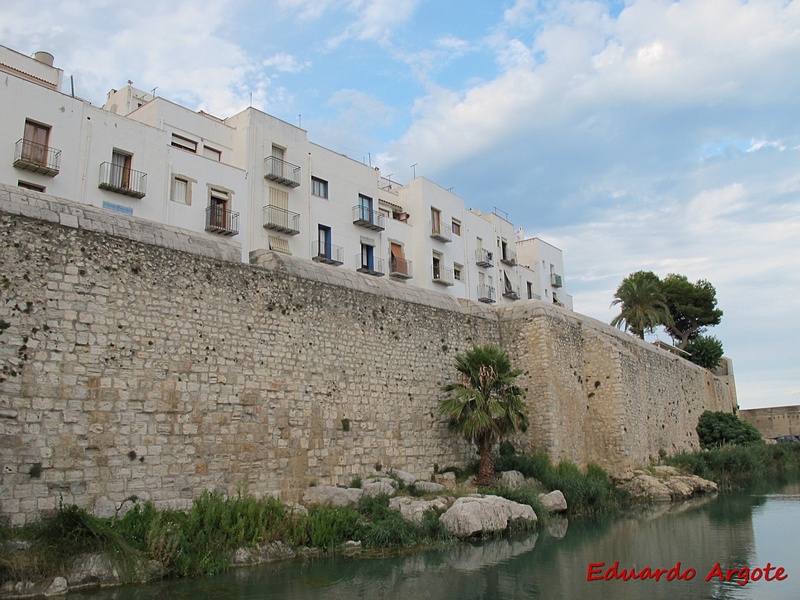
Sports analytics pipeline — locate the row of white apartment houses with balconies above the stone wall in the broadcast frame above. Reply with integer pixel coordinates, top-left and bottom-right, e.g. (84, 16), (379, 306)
(0, 46), (572, 308)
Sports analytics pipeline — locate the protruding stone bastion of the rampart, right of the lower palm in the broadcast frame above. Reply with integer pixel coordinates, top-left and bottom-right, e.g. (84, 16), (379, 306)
(499, 302), (736, 475)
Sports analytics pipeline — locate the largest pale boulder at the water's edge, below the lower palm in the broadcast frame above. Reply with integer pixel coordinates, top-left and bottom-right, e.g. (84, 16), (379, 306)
(441, 494), (537, 537)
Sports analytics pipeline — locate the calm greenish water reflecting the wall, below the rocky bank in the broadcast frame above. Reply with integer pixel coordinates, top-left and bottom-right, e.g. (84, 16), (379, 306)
(67, 484), (800, 600)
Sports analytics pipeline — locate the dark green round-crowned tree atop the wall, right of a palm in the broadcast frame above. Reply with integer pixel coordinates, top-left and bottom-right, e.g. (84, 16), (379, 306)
(661, 274), (722, 349)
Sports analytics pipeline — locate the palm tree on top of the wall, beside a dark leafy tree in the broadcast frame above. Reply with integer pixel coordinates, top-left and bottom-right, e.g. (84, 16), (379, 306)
(611, 271), (670, 339)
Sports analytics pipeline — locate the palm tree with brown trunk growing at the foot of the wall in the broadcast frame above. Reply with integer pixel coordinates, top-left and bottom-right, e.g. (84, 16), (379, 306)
(439, 344), (528, 486)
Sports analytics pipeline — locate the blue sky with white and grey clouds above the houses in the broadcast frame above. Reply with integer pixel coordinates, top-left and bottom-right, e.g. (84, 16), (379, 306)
(0, 0), (800, 408)
